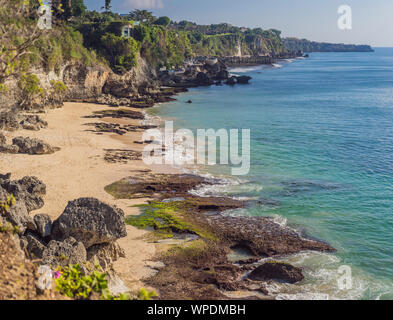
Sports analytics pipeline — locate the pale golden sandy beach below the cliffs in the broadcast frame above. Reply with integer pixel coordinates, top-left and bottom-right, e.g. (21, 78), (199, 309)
(0, 103), (174, 290)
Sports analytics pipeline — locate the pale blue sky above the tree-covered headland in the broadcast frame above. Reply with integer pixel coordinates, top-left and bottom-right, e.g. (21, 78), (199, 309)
(84, 0), (393, 47)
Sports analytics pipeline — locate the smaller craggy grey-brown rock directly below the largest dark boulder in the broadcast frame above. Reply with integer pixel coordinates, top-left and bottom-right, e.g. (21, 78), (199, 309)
(41, 237), (86, 267)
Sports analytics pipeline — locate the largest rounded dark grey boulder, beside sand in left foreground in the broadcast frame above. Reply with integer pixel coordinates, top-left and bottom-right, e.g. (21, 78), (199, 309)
(52, 198), (127, 249)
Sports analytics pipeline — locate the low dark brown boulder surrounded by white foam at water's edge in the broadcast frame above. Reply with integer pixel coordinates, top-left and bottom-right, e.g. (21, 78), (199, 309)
(248, 261), (304, 283)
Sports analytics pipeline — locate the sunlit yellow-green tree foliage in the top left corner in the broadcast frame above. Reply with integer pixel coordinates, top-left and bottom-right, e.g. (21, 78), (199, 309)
(0, 0), (42, 84)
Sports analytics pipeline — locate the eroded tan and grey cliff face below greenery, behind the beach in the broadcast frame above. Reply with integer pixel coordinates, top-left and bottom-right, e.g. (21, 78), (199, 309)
(0, 58), (158, 111)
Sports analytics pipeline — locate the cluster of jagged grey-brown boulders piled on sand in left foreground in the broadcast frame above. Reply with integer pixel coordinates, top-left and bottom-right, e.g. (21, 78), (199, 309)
(0, 174), (127, 272)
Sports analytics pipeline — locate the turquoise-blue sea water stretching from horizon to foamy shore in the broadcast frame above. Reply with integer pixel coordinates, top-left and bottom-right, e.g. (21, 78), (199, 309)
(149, 48), (393, 299)
